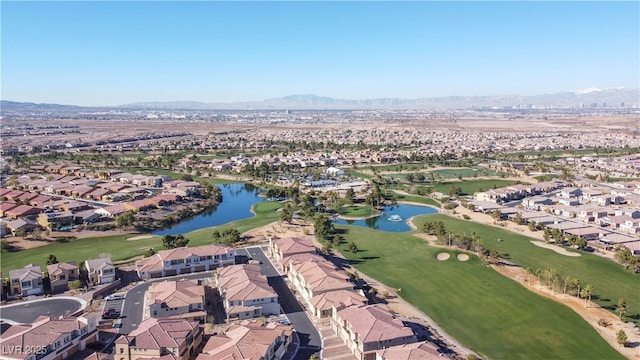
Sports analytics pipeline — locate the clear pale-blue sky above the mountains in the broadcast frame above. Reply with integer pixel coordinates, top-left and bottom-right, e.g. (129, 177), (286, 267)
(0, 1), (640, 105)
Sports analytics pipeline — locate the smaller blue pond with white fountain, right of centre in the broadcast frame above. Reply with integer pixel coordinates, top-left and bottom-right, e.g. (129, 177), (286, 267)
(333, 204), (438, 232)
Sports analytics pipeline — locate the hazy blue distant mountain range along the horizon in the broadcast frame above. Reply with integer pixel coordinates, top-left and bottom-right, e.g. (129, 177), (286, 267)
(0, 88), (640, 111)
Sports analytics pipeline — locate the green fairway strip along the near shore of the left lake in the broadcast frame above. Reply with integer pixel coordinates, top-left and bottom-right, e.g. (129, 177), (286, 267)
(2, 201), (282, 275)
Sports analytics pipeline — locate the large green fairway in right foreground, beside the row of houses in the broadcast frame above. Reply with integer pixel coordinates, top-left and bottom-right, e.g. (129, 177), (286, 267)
(336, 225), (623, 359)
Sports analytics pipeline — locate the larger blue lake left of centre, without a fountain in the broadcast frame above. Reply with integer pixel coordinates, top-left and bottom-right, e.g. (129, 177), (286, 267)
(152, 183), (266, 235)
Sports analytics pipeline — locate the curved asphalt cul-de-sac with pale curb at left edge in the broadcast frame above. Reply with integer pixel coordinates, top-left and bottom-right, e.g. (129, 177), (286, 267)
(0, 297), (83, 323)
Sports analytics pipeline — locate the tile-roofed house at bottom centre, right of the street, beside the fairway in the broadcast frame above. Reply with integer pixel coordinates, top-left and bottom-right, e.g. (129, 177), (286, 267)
(331, 304), (417, 360)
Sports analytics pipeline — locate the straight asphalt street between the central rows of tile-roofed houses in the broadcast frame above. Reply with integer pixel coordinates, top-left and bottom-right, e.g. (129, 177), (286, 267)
(236, 247), (322, 359)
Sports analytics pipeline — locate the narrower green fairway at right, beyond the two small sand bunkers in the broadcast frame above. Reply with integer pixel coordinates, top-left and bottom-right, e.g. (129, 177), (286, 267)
(414, 214), (640, 325)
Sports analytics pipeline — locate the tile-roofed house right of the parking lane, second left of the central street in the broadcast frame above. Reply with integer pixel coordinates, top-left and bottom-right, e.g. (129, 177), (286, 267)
(145, 279), (206, 320)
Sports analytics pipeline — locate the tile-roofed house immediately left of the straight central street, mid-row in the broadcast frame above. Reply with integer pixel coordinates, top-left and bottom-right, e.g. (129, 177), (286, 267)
(216, 264), (280, 320)
